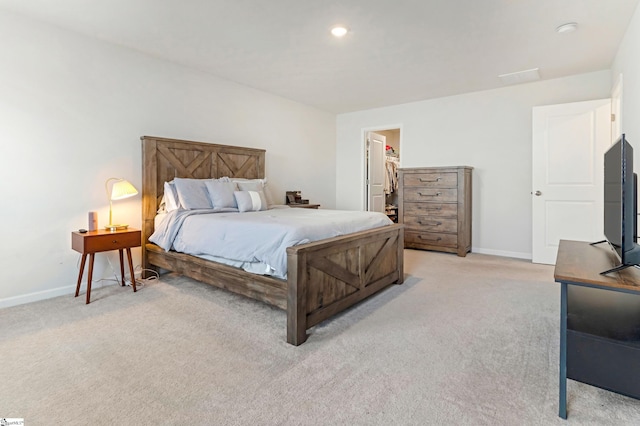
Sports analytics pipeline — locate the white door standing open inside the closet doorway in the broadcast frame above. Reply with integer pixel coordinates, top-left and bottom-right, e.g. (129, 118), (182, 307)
(367, 132), (387, 213)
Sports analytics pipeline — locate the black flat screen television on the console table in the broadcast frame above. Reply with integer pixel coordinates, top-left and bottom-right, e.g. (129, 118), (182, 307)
(601, 134), (640, 274)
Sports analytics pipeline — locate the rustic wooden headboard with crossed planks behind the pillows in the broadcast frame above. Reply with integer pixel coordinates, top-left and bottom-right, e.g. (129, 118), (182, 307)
(140, 136), (265, 245)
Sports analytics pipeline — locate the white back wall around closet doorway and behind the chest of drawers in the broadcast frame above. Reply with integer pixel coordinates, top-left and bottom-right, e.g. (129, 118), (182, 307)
(336, 70), (608, 258)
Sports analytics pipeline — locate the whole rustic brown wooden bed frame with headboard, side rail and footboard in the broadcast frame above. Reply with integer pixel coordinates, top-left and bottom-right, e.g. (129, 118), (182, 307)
(141, 136), (404, 346)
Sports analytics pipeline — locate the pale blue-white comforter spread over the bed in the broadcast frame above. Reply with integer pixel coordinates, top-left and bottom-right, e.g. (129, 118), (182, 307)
(149, 208), (393, 278)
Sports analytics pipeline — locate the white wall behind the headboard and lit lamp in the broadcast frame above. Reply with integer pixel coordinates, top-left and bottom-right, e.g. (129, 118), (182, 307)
(0, 11), (336, 307)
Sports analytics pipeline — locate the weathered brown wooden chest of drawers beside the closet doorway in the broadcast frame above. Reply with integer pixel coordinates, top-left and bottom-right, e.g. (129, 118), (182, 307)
(398, 166), (473, 256)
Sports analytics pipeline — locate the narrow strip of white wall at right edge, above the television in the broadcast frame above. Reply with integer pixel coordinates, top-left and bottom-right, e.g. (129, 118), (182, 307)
(611, 2), (640, 151)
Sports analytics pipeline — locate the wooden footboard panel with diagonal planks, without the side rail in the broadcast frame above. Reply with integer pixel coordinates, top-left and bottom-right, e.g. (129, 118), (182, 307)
(287, 225), (404, 346)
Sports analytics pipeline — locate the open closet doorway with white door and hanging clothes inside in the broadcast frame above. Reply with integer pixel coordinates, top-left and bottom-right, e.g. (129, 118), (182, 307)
(364, 128), (400, 222)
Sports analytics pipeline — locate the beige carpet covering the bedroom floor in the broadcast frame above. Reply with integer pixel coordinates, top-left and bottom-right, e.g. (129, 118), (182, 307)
(0, 250), (640, 425)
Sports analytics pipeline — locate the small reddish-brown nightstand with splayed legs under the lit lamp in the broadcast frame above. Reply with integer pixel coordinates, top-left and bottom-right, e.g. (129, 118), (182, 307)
(71, 228), (142, 304)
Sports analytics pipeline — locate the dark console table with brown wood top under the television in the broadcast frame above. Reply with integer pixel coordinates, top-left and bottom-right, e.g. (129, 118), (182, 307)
(554, 240), (640, 419)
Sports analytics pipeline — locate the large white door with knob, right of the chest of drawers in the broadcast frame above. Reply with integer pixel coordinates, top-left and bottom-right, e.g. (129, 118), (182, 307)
(531, 99), (611, 264)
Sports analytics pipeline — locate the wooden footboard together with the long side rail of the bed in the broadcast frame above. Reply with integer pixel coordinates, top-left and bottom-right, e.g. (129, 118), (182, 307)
(144, 225), (404, 346)
